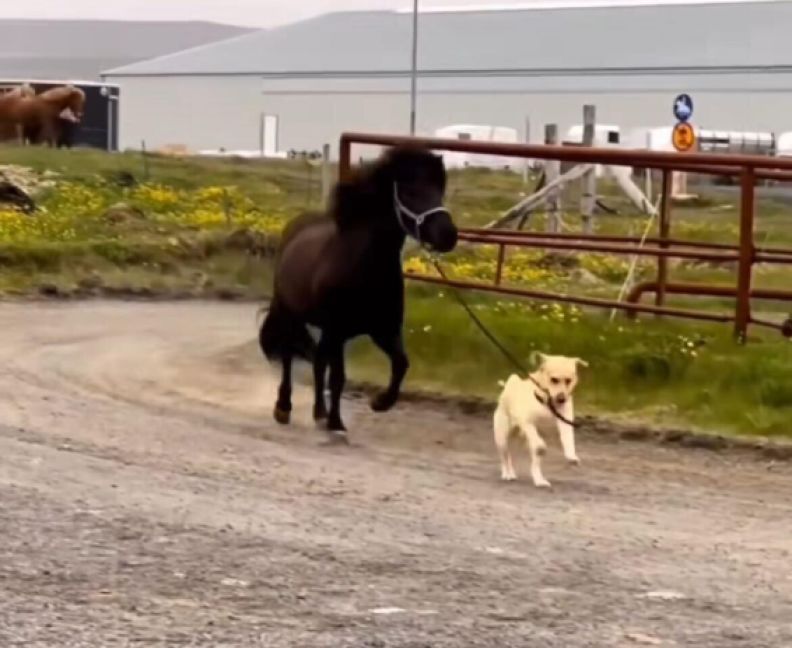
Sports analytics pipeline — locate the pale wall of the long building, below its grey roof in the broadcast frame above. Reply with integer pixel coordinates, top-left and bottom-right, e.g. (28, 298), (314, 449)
(109, 72), (792, 156)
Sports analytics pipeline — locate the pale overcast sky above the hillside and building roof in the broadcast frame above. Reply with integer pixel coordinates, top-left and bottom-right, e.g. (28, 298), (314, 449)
(0, 0), (780, 27)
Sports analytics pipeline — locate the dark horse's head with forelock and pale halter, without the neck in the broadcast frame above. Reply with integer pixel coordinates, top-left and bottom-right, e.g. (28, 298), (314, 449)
(373, 146), (457, 252)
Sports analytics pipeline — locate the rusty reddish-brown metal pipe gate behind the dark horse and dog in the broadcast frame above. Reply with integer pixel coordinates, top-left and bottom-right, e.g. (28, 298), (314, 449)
(339, 133), (792, 341)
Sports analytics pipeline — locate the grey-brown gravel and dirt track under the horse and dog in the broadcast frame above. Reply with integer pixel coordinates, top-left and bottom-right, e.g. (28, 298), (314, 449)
(0, 303), (792, 648)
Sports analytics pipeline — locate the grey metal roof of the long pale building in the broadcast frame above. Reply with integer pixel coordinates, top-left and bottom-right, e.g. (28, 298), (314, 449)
(105, 0), (792, 77)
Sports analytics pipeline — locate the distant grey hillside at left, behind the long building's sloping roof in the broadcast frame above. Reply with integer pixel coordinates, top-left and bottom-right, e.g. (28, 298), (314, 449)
(0, 20), (253, 81)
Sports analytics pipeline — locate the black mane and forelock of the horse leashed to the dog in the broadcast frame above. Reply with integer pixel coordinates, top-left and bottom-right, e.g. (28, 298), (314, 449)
(328, 145), (445, 229)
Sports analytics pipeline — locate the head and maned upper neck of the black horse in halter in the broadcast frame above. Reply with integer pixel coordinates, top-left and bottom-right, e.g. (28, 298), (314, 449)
(333, 146), (457, 252)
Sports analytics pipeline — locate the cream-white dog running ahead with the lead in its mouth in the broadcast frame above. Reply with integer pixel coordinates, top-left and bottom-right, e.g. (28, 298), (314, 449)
(493, 353), (588, 488)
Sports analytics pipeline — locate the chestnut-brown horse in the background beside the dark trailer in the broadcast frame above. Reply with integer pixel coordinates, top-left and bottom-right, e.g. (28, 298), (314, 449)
(0, 85), (85, 146)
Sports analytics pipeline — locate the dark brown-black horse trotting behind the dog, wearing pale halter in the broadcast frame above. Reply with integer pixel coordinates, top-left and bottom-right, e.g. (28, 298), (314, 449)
(259, 147), (457, 438)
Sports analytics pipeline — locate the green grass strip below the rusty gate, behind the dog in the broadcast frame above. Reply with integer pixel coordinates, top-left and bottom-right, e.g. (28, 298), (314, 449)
(351, 288), (792, 437)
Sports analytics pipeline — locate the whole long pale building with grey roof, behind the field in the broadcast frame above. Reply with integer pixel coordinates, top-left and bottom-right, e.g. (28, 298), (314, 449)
(104, 0), (792, 157)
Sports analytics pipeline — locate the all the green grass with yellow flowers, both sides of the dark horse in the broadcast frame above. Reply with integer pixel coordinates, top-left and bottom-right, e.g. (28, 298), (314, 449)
(0, 148), (792, 436)
